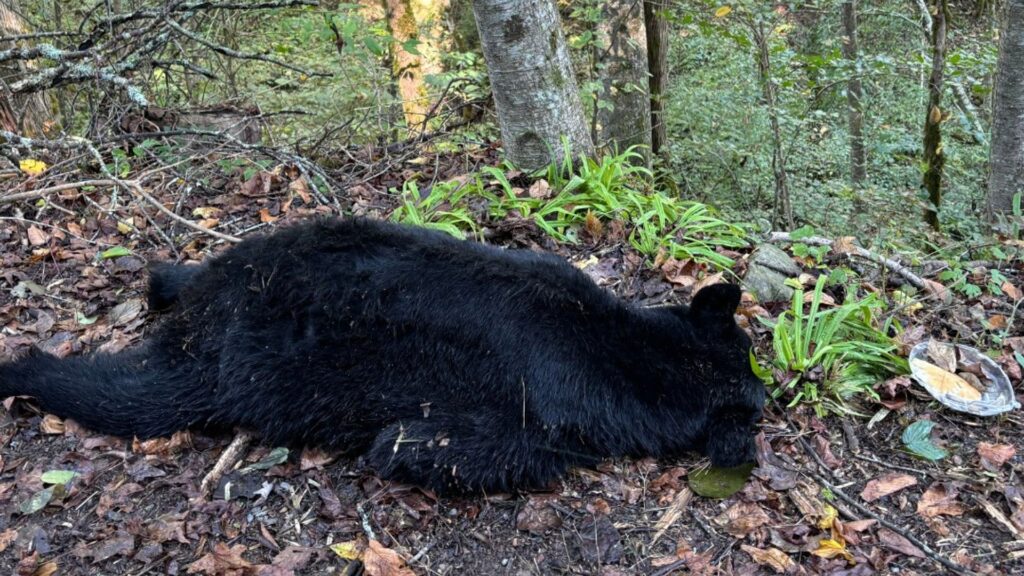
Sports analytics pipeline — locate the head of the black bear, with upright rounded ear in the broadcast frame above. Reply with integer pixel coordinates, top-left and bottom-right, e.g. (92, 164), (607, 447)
(686, 284), (765, 467)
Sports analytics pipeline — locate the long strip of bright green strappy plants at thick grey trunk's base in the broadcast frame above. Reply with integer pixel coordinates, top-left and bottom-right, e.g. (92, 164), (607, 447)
(392, 149), (750, 269)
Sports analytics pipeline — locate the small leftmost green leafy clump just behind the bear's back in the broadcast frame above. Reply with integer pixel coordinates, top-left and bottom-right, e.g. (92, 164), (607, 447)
(391, 180), (479, 239)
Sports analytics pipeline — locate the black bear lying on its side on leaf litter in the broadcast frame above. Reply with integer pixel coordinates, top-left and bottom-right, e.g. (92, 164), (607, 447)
(0, 219), (765, 492)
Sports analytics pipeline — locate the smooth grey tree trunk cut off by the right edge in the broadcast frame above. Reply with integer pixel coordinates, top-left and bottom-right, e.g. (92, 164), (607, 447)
(988, 0), (1024, 215)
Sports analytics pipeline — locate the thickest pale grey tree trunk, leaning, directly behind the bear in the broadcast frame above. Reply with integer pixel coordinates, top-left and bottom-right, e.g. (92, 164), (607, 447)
(473, 0), (594, 170)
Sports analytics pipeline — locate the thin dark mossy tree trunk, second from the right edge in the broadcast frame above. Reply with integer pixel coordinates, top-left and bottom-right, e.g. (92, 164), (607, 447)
(922, 0), (946, 231)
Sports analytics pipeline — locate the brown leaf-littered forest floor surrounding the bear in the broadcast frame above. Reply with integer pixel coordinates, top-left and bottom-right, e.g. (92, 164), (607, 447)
(0, 148), (1024, 576)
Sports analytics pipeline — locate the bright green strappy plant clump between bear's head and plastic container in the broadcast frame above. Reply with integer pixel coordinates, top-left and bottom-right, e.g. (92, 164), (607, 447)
(765, 276), (908, 415)
